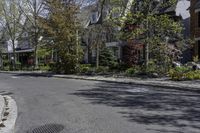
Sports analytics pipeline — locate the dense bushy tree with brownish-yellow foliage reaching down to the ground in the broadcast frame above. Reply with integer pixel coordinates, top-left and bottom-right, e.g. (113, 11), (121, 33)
(40, 0), (82, 73)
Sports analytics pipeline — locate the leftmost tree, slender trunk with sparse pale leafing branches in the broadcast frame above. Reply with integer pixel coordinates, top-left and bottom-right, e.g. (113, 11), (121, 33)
(0, 0), (24, 69)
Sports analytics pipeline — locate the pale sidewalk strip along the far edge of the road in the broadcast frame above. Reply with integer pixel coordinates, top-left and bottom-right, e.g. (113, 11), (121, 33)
(0, 71), (200, 92)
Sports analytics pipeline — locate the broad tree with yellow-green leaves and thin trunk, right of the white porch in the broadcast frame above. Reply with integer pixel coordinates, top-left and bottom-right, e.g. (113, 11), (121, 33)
(105, 0), (183, 72)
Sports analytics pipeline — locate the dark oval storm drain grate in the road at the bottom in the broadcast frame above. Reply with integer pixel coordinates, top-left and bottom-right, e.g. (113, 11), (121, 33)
(27, 124), (64, 133)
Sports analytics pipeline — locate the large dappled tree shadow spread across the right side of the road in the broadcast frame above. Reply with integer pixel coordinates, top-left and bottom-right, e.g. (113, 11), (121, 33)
(73, 83), (200, 133)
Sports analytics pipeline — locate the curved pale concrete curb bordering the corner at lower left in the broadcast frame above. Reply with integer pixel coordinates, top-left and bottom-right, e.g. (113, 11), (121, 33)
(0, 96), (17, 133)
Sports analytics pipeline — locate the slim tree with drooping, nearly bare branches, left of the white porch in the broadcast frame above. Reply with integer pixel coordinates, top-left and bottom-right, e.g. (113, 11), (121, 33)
(86, 0), (117, 68)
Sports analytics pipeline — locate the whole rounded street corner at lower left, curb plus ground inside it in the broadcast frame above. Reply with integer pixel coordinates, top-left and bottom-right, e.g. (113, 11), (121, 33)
(0, 95), (17, 133)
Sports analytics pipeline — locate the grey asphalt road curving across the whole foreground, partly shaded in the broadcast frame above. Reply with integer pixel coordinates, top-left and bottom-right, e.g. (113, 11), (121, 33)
(0, 73), (200, 133)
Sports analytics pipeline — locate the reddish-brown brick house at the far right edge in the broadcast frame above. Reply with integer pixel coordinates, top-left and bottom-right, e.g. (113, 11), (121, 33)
(190, 0), (200, 58)
